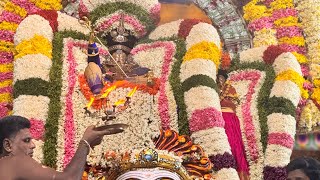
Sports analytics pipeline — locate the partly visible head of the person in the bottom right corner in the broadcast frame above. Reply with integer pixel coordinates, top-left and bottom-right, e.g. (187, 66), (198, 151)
(287, 157), (320, 180)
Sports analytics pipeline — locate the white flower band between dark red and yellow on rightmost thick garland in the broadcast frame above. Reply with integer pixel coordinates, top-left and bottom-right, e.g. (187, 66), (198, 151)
(272, 52), (302, 76)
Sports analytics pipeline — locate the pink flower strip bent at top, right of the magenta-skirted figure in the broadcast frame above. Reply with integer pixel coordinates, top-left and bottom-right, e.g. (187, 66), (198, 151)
(230, 70), (261, 161)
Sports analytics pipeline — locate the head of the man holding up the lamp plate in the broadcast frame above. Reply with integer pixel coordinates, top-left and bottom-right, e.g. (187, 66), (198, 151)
(0, 116), (35, 156)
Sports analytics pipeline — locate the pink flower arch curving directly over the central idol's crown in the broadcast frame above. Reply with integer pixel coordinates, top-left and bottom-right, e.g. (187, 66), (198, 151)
(97, 14), (147, 37)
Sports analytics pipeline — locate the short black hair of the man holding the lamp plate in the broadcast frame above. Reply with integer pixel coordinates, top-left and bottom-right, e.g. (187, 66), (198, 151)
(0, 116), (30, 154)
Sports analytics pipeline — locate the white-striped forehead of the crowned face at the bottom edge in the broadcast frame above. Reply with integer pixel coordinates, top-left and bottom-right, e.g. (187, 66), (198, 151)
(117, 169), (182, 180)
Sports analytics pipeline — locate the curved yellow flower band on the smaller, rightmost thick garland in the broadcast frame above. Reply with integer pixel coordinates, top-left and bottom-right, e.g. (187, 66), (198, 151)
(276, 69), (309, 99)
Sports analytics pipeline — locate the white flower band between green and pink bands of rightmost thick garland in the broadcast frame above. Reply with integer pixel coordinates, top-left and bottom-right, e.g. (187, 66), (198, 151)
(267, 113), (296, 139)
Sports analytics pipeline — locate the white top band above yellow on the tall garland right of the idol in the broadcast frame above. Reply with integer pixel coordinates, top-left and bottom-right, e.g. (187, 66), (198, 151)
(186, 23), (220, 50)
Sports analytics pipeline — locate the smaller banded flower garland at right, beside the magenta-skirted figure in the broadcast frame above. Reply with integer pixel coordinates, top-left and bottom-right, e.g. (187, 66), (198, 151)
(230, 46), (304, 179)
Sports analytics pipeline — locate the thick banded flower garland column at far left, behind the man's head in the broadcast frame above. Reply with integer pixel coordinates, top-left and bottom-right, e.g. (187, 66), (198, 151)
(13, 7), (57, 165)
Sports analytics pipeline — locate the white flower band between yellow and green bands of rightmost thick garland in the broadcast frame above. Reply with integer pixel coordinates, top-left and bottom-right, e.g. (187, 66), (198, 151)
(270, 80), (300, 106)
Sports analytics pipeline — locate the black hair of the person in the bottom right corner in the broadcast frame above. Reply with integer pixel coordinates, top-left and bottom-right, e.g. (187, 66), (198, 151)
(287, 157), (320, 180)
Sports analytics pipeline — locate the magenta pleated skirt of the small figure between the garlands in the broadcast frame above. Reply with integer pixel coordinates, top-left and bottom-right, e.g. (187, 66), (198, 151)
(222, 112), (249, 173)
